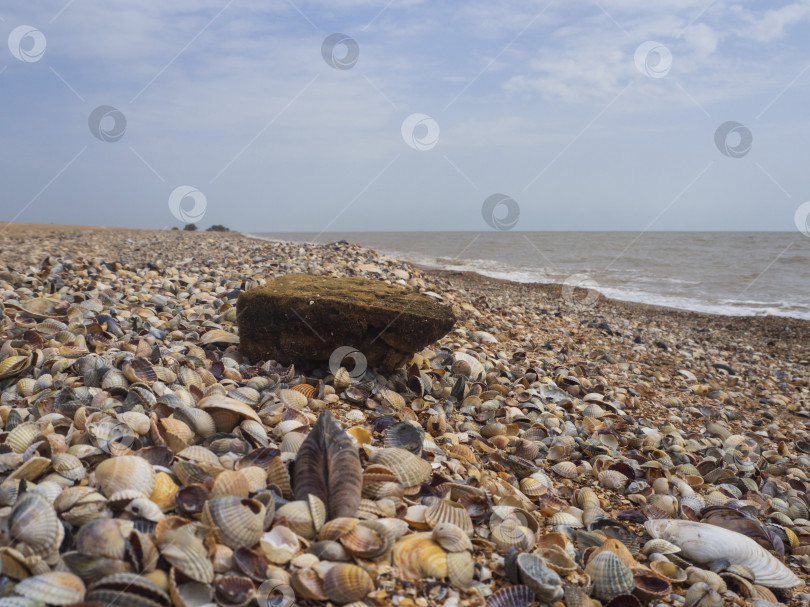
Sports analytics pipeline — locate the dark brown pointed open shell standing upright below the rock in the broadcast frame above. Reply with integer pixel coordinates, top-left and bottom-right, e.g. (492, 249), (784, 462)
(293, 411), (363, 519)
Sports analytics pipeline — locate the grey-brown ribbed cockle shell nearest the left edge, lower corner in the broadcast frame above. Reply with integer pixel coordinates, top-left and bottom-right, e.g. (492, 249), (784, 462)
(0, 492), (60, 556)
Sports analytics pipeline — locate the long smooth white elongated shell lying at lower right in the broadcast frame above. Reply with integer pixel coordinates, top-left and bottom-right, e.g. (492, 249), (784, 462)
(644, 519), (802, 588)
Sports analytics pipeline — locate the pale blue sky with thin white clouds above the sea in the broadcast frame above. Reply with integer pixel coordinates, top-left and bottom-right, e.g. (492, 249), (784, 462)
(0, 0), (810, 233)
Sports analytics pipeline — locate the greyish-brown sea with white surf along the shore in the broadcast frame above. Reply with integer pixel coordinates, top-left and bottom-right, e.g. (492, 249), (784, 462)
(248, 232), (810, 319)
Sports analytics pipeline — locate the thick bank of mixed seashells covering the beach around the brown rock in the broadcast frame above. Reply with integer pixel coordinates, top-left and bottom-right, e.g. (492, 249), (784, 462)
(0, 229), (810, 607)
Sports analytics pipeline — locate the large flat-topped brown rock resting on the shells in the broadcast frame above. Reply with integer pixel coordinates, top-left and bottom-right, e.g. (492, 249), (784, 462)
(236, 274), (456, 370)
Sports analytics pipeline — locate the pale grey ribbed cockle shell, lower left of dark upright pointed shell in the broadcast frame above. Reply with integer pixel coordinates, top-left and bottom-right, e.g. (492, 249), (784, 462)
(201, 495), (264, 548)
